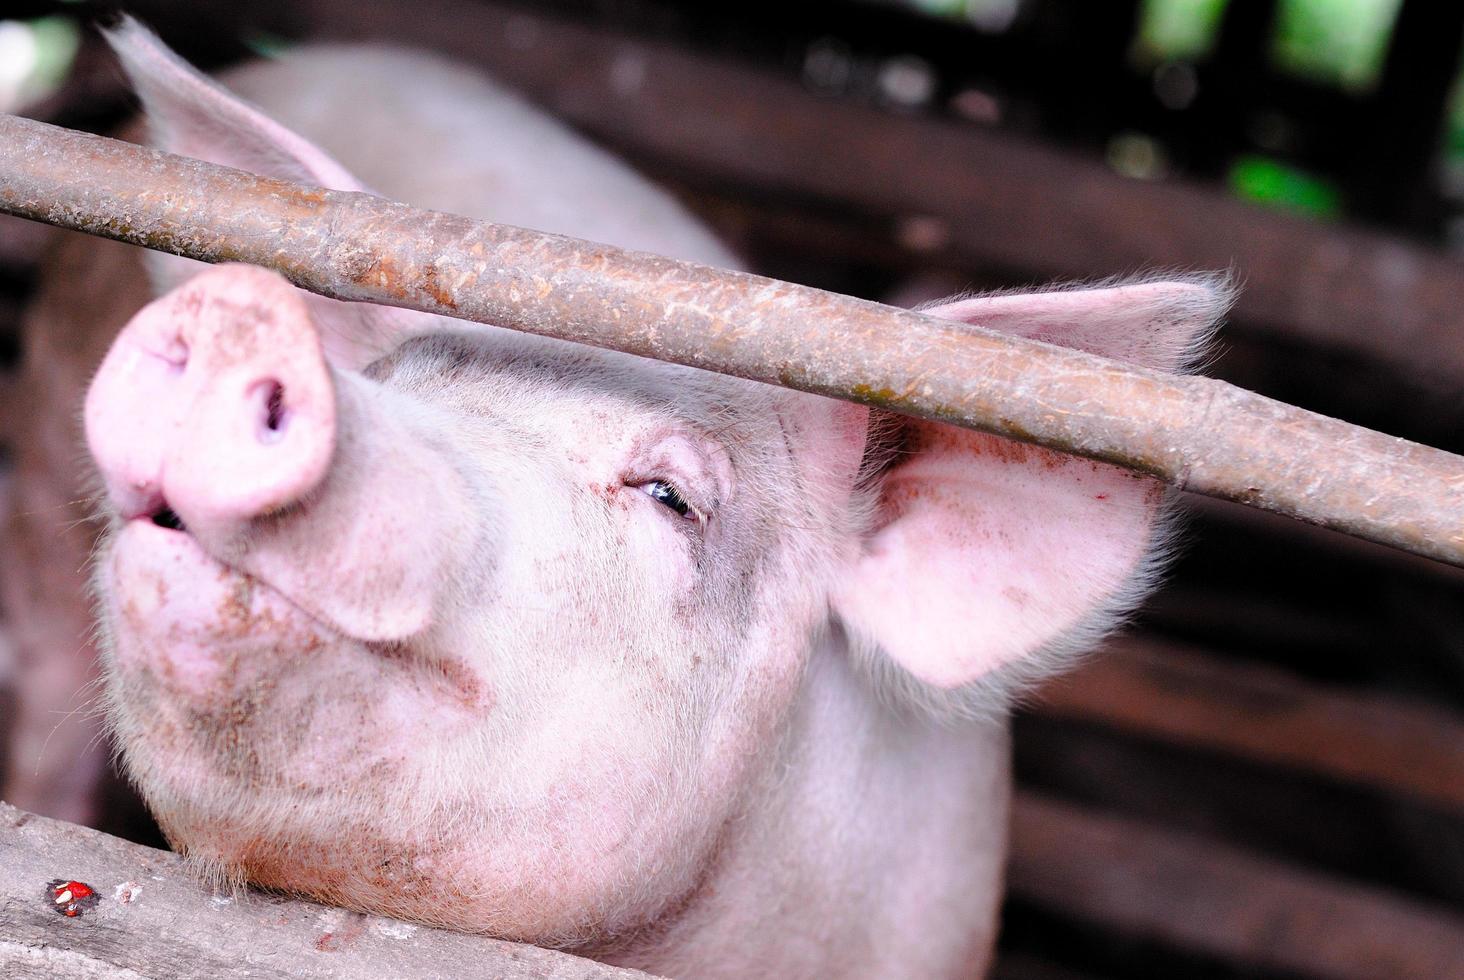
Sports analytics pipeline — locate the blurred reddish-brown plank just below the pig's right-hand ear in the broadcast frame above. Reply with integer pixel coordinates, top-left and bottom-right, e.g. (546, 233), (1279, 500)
(1035, 636), (1464, 812)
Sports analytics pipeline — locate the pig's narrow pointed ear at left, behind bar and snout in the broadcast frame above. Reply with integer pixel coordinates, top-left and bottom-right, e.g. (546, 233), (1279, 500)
(105, 16), (418, 368)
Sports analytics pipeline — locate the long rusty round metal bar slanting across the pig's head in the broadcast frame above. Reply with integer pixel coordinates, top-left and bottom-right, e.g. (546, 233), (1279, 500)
(0, 117), (1464, 565)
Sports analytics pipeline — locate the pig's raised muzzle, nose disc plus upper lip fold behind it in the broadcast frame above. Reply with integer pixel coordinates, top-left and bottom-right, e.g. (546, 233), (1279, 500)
(85, 265), (473, 642)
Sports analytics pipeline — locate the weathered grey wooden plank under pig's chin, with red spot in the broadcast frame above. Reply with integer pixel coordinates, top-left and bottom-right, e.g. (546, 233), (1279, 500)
(0, 803), (647, 980)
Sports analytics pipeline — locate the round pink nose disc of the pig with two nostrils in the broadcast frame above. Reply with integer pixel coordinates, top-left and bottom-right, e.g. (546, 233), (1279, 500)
(85, 265), (337, 539)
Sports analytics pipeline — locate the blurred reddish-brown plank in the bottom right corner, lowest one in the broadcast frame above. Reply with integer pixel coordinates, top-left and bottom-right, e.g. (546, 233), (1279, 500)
(1009, 792), (1464, 980)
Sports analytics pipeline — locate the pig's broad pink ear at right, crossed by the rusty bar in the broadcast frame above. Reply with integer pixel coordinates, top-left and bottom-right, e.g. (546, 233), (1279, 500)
(833, 280), (1230, 708)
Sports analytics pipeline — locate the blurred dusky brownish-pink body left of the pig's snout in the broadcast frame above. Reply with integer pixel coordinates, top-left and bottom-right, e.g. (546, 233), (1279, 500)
(0, 219), (151, 825)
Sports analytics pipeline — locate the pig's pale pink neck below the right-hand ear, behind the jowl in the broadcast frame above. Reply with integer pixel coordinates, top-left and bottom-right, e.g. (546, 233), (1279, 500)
(603, 636), (1009, 977)
